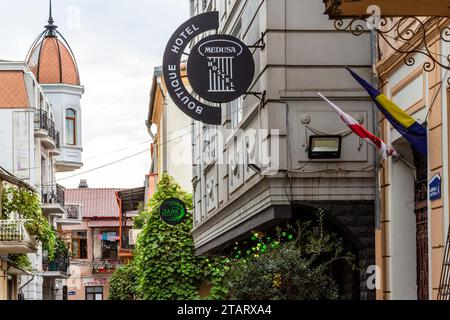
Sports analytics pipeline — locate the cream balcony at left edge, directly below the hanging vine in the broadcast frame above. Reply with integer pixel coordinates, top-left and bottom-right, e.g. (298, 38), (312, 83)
(0, 220), (37, 253)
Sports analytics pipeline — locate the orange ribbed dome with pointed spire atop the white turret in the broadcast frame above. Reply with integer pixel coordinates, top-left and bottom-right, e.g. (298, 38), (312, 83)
(27, 0), (80, 86)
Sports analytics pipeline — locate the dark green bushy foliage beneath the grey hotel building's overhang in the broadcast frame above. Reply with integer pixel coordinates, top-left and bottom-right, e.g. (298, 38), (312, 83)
(224, 217), (354, 300)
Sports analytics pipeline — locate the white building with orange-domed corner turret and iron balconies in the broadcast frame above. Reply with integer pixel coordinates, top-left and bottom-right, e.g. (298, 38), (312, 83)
(0, 5), (84, 300)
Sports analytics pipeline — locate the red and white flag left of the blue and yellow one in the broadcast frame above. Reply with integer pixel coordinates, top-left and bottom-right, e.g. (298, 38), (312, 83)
(319, 93), (398, 159)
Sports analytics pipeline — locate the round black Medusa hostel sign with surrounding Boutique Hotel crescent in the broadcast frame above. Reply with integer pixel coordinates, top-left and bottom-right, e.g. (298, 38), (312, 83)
(163, 11), (255, 125)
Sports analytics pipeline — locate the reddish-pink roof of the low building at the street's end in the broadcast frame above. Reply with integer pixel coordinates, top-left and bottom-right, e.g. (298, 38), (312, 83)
(65, 188), (121, 219)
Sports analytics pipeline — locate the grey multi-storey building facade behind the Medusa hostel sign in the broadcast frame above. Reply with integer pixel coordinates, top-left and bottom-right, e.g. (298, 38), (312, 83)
(188, 0), (376, 299)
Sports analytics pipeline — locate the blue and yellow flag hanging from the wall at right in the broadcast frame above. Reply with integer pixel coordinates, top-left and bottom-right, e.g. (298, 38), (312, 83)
(347, 68), (427, 157)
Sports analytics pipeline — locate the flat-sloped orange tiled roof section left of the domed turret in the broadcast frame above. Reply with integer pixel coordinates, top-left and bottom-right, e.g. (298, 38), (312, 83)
(0, 71), (30, 108)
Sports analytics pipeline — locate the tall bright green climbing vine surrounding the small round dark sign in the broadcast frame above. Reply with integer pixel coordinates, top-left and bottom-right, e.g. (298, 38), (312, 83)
(110, 174), (228, 300)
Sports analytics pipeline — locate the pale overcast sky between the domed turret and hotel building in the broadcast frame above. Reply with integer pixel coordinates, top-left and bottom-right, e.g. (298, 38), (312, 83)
(0, 0), (189, 188)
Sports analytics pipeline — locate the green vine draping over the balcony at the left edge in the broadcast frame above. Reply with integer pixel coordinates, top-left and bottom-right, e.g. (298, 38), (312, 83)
(1, 187), (56, 259)
